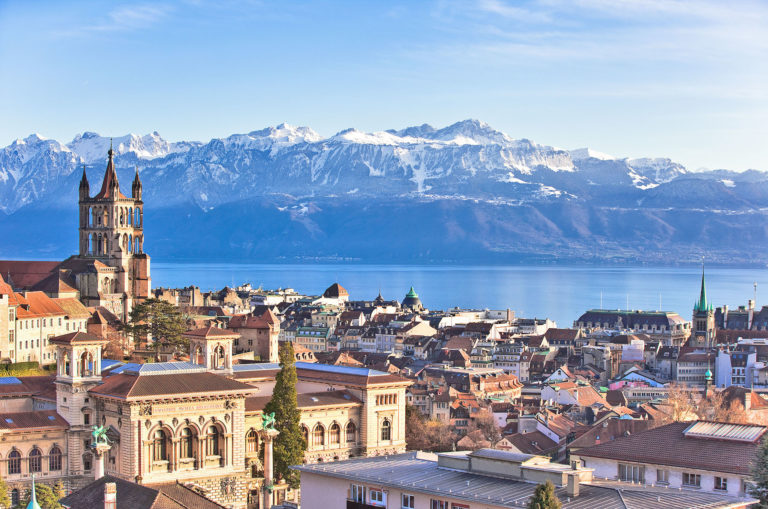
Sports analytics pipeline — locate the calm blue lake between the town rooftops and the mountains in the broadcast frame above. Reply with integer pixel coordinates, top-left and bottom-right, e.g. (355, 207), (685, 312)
(152, 263), (768, 327)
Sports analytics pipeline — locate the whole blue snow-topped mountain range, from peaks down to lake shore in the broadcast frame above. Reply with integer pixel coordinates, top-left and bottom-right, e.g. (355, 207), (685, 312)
(0, 120), (768, 266)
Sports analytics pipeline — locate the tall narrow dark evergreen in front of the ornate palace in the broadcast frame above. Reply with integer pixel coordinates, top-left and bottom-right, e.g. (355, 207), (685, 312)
(264, 342), (307, 488)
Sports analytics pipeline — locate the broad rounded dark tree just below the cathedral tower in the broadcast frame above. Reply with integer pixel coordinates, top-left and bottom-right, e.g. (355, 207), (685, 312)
(122, 299), (189, 360)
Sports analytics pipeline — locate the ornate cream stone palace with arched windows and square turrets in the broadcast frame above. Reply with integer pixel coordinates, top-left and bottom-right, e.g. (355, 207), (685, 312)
(0, 331), (410, 509)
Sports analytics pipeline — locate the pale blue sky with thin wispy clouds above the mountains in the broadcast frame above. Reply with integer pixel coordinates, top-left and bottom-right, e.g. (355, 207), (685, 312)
(0, 0), (768, 171)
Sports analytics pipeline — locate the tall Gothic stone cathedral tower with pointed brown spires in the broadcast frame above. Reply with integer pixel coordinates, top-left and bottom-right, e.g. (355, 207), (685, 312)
(77, 143), (150, 320)
